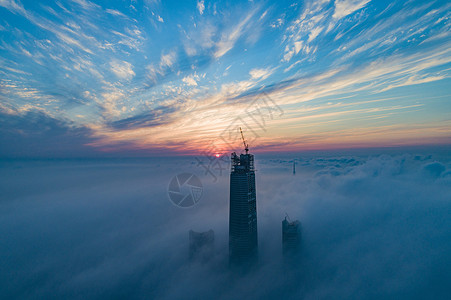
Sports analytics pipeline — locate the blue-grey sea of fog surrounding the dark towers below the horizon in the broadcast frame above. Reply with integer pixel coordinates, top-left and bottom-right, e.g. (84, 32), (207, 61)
(0, 149), (451, 299)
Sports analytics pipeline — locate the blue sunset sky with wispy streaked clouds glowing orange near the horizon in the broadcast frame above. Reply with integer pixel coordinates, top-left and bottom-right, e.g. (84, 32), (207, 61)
(0, 0), (451, 157)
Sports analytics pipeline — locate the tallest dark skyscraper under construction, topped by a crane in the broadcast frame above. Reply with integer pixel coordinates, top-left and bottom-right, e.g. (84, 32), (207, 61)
(229, 127), (258, 264)
